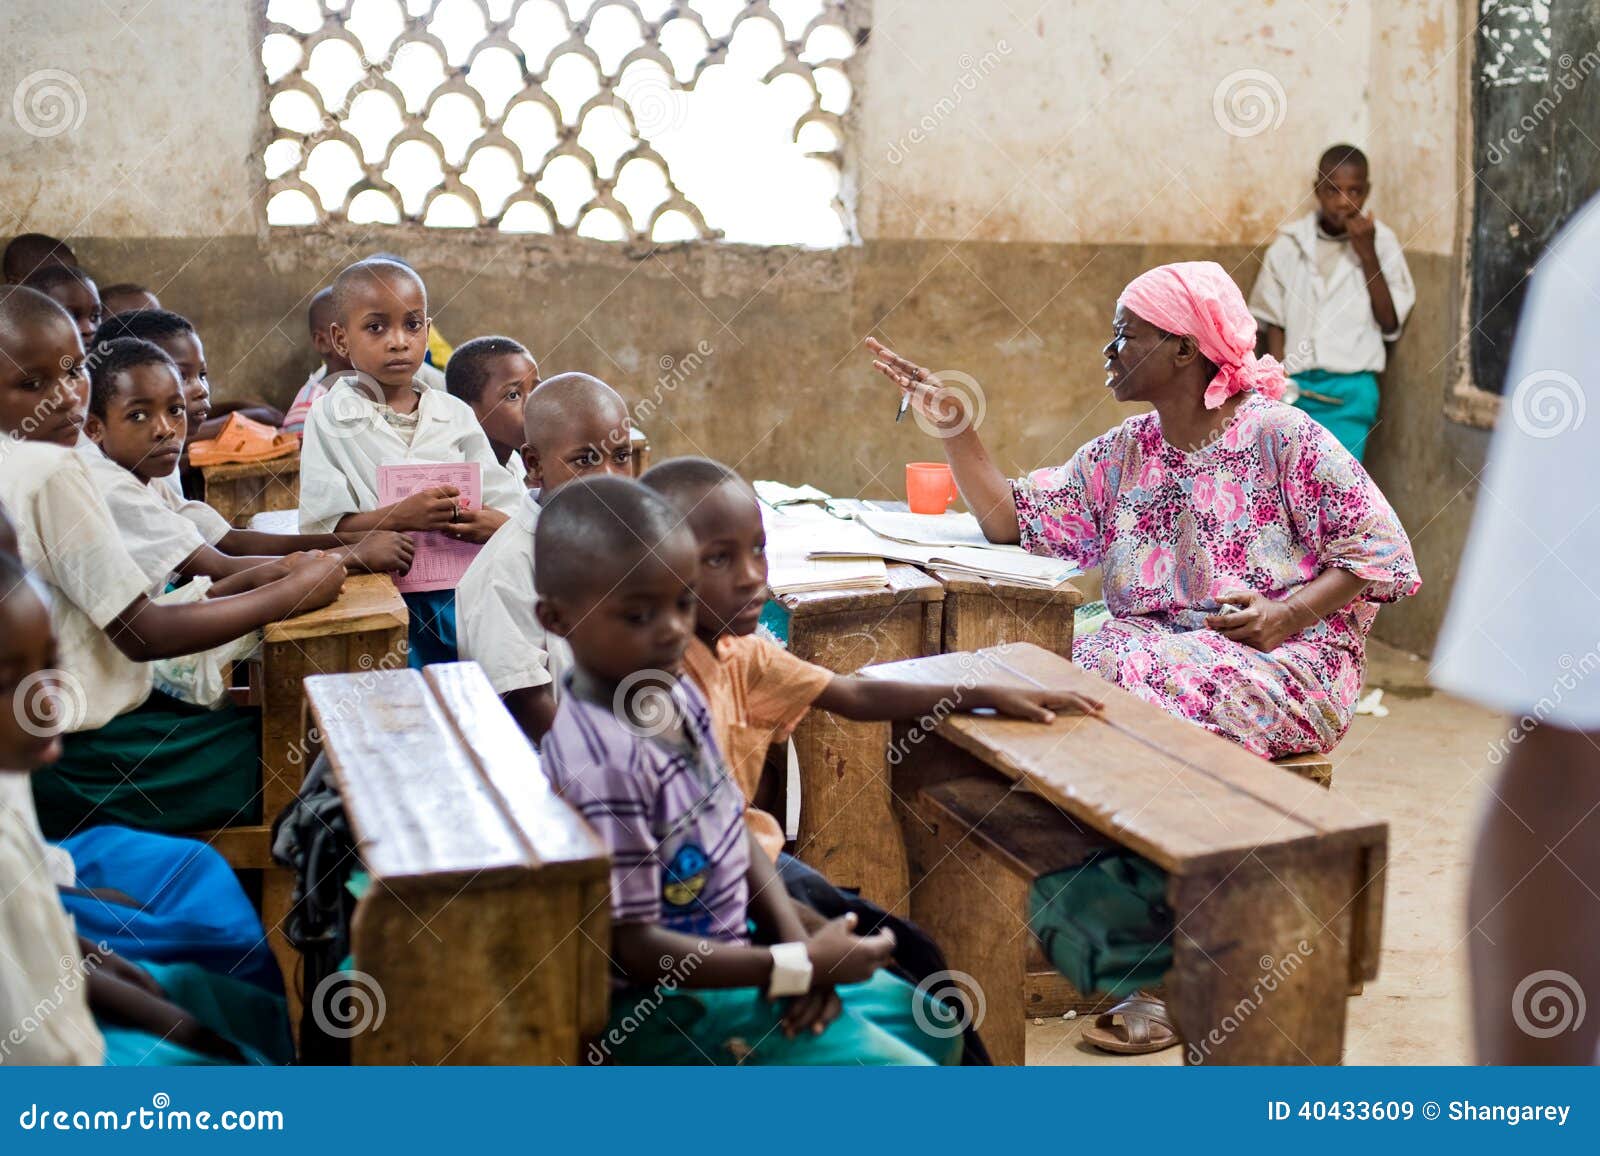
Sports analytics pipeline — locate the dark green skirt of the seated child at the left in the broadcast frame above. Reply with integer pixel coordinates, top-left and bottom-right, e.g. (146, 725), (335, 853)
(34, 692), (261, 839)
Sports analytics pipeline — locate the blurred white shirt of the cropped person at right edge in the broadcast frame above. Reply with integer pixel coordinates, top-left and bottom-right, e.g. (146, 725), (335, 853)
(1432, 200), (1600, 730)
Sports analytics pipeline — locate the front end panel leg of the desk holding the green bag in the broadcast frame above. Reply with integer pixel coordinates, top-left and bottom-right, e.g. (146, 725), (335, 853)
(1166, 849), (1365, 1065)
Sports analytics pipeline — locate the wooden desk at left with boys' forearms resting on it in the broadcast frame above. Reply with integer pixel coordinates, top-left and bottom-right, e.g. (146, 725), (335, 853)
(195, 575), (408, 1005)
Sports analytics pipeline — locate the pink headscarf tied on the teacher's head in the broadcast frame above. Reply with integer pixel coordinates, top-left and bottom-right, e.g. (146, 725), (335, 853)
(1117, 261), (1288, 410)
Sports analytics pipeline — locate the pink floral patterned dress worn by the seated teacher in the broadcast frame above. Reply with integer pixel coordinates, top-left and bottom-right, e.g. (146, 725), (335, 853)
(1011, 394), (1421, 759)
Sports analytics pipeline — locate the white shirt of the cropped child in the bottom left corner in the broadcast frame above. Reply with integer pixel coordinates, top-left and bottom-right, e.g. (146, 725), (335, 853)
(0, 784), (106, 1066)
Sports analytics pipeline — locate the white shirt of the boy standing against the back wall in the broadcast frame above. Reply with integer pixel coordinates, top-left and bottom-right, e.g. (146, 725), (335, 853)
(1250, 213), (1416, 373)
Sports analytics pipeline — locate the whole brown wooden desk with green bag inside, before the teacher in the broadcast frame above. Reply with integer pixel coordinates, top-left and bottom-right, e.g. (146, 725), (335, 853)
(866, 644), (1387, 1063)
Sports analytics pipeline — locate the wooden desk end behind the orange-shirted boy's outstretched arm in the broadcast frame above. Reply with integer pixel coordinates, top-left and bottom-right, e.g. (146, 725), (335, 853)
(778, 564), (944, 914)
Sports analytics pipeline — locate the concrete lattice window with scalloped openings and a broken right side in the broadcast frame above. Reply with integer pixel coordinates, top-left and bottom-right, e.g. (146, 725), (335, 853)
(261, 0), (866, 247)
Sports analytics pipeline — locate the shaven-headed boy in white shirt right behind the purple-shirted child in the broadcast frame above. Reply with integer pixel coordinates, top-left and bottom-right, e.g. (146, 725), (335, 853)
(450, 373), (634, 745)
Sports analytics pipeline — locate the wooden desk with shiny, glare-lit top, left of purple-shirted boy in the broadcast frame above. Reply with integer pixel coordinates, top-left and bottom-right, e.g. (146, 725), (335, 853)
(306, 663), (611, 1065)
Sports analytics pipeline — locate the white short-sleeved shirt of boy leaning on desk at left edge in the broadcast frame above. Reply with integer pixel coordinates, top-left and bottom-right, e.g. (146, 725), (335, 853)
(0, 439), (150, 730)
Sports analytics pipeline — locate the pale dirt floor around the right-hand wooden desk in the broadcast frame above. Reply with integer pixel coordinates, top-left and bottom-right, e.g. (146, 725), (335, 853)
(1027, 644), (1504, 1065)
